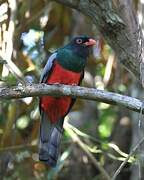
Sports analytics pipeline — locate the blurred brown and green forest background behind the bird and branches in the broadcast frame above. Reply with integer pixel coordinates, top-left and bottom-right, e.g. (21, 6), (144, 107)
(0, 0), (143, 180)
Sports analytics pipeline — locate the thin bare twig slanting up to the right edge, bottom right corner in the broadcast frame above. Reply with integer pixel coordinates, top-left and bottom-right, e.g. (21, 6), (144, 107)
(112, 137), (144, 180)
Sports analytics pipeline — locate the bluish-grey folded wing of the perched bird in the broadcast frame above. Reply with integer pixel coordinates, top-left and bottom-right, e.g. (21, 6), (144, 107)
(40, 52), (57, 83)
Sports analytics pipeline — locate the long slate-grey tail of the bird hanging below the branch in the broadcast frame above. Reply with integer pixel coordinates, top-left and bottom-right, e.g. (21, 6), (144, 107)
(39, 112), (63, 167)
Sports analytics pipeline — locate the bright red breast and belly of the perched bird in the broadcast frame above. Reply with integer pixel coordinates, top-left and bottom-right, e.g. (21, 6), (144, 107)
(41, 63), (82, 123)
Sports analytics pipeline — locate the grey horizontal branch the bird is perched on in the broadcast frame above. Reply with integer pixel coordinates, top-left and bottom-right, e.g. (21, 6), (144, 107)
(0, 84), (143, 112)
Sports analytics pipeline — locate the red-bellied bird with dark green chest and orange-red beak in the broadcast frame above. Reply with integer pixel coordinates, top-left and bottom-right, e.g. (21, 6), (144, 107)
(39, 35), (96, 167)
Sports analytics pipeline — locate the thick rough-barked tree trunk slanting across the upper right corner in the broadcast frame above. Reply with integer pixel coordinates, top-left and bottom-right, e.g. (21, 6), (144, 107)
(52, 0), (144, 85)
